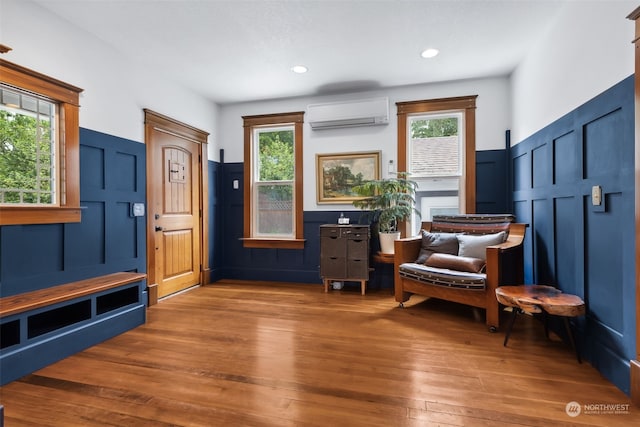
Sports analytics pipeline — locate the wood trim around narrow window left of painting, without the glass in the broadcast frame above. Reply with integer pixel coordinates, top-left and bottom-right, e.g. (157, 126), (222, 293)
(241, 111), (305, 249)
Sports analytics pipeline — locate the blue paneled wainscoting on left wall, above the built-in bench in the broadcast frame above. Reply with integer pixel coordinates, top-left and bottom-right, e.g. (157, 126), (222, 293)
(0, 129), (146, 296)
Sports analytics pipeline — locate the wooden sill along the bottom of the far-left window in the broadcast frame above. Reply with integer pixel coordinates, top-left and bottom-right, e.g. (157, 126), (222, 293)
(0, 206), (81, 225)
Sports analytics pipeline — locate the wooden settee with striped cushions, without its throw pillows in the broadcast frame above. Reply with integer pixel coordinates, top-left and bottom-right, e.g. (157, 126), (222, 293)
(394, 214), (527, 332)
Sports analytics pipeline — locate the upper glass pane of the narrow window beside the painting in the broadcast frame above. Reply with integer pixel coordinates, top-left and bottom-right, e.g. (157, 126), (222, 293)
(256, 127), (294, 181)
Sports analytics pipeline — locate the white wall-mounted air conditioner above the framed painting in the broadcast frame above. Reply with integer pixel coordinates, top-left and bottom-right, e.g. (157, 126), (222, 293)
(305, 97), (389, 130)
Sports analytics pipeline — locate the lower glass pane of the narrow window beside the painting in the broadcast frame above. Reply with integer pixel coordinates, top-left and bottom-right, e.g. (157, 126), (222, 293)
(256, 182), (293, 237)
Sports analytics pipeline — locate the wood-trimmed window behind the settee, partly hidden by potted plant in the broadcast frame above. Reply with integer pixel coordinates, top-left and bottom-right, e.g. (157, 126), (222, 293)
(397, 96), (476, 235)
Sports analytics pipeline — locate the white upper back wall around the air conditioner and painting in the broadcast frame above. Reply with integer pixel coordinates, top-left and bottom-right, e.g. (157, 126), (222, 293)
(218, 77), (511, 210)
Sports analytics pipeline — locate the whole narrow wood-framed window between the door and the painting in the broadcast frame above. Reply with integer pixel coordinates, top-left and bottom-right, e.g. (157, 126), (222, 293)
(243, 112), (304, 249)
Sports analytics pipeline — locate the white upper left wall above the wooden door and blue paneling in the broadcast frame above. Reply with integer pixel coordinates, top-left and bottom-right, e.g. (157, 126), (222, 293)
(0, 0), (218, 153)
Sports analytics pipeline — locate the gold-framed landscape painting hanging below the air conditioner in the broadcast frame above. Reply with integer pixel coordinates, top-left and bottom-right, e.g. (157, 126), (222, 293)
(316, 151), (380, 203)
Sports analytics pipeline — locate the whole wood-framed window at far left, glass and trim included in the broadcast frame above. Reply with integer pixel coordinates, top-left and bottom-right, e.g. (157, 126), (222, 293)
(0, 60), (82, 225)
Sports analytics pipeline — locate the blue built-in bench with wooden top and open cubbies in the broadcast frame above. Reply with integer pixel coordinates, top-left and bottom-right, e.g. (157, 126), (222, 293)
(0, 272), (146, 385)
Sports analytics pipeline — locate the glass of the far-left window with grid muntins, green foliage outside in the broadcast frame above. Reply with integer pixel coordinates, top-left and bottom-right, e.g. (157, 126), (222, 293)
(0, 86), (56, 205)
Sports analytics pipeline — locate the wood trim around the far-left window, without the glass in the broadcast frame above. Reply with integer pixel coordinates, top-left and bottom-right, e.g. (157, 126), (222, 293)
(0, 59), (83, 225)
